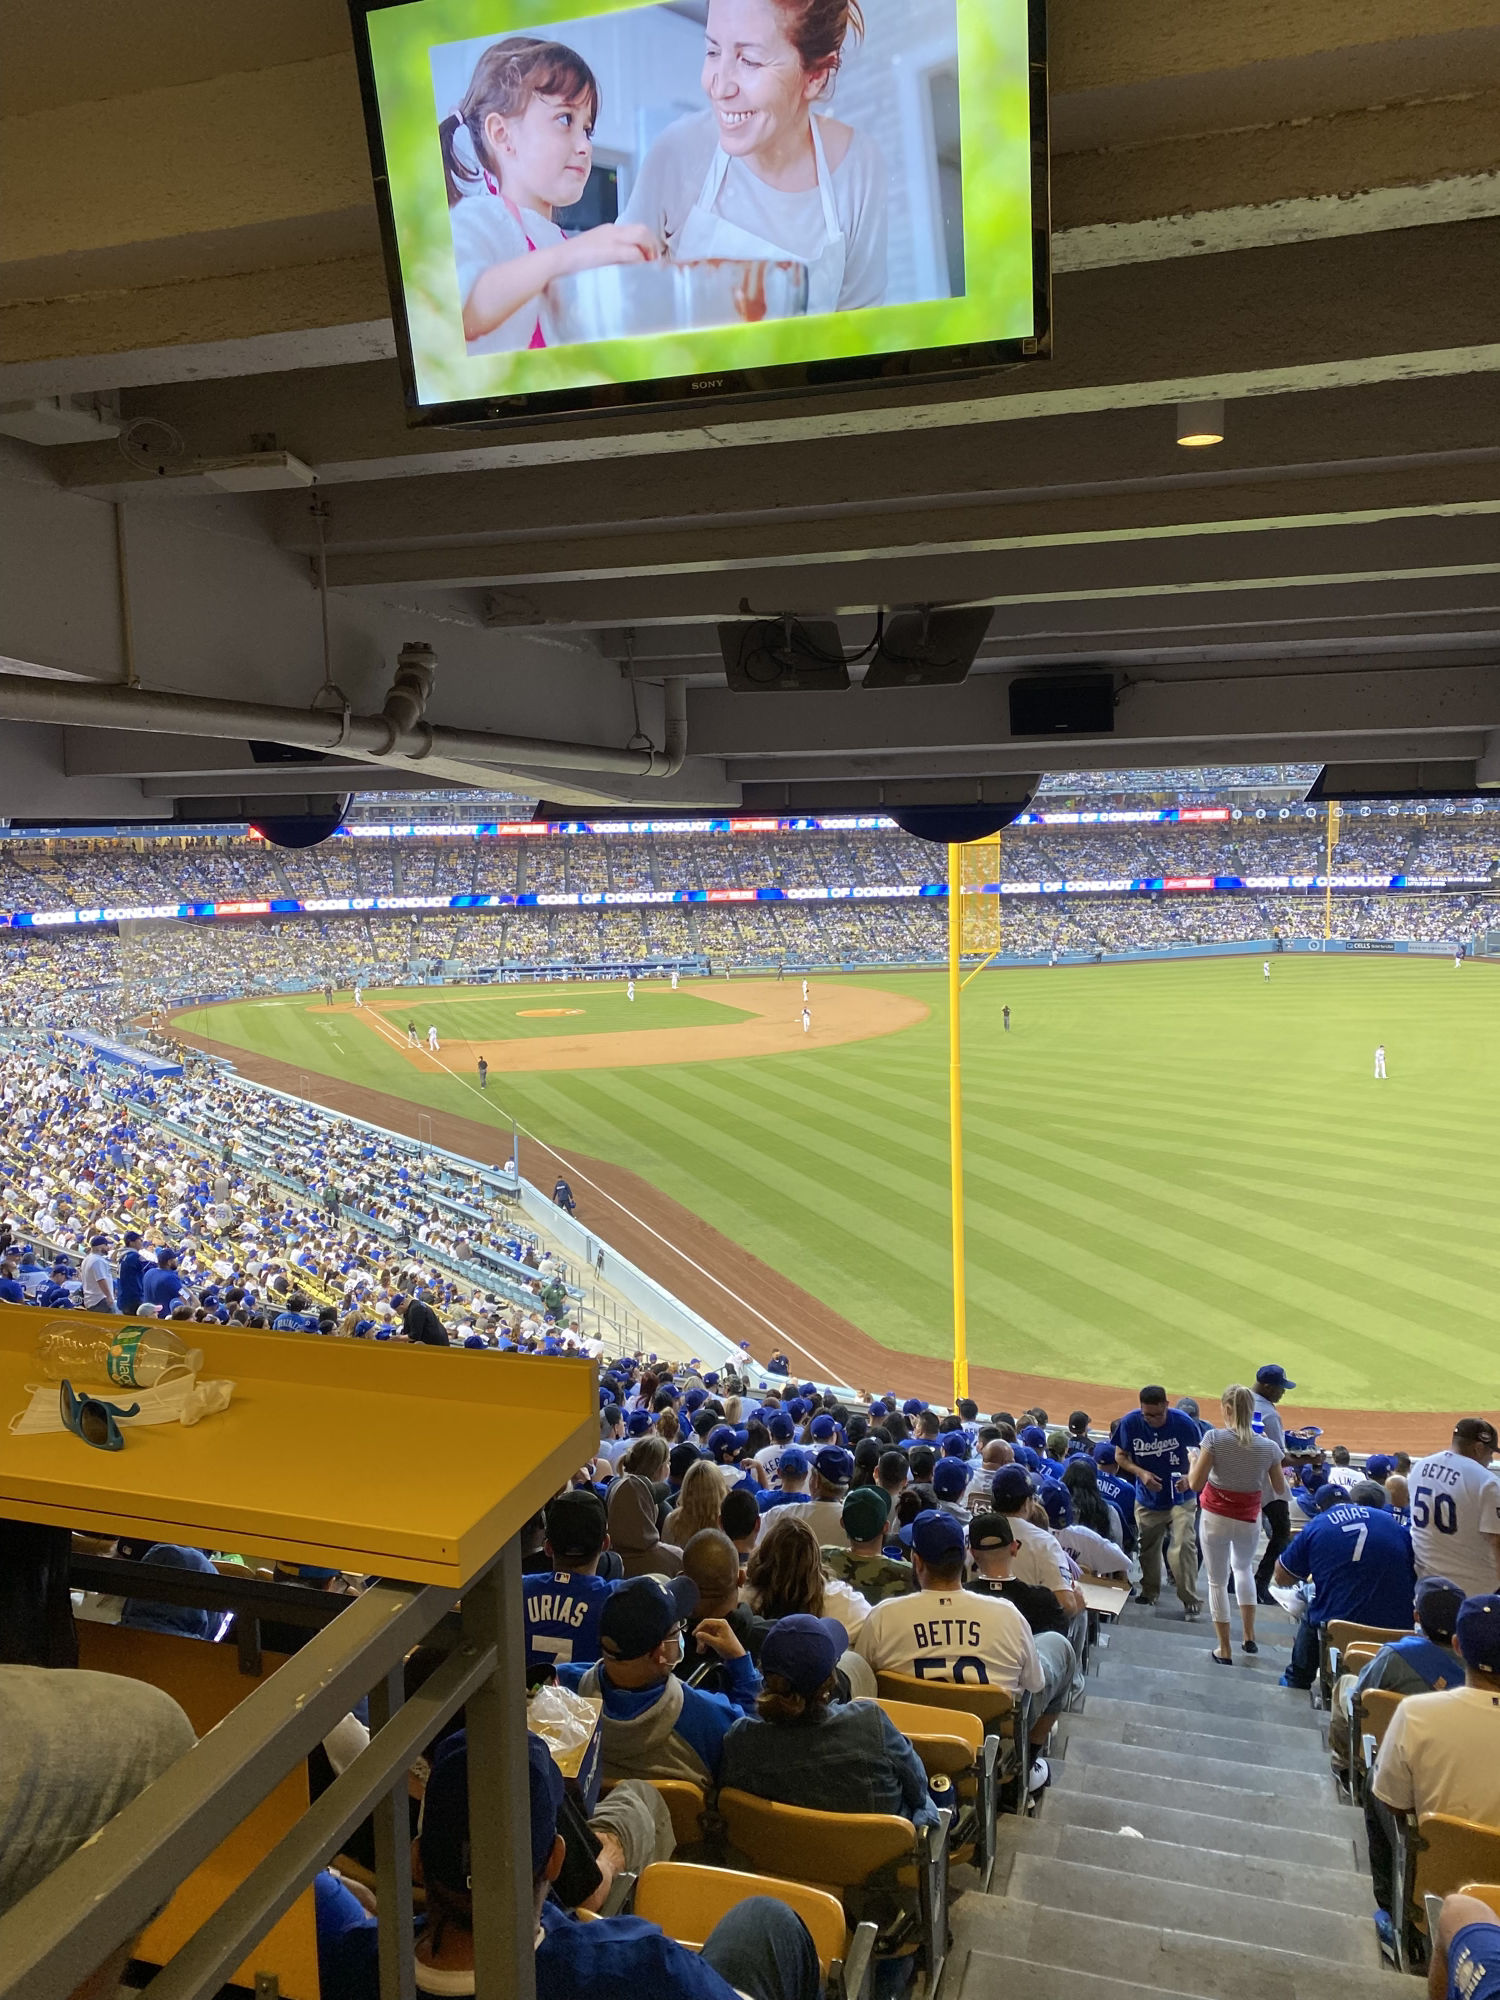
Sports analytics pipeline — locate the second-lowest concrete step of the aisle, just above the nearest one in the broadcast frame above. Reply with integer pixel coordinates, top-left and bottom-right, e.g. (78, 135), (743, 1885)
(1006, 1842), (1380, 1966)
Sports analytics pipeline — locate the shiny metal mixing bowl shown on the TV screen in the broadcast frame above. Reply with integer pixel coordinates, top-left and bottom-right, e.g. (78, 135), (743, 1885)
(546, 258), (808, 346)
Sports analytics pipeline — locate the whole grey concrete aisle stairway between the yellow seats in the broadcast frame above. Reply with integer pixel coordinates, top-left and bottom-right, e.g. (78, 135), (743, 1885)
(942, 1600), (1424, 2000)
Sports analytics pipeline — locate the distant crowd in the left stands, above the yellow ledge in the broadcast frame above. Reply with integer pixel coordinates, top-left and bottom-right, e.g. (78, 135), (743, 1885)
(0, 1046), (600, 1354)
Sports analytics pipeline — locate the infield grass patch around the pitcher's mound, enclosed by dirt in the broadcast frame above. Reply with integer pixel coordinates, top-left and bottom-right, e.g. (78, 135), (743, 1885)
(354, 980), (750, 1054)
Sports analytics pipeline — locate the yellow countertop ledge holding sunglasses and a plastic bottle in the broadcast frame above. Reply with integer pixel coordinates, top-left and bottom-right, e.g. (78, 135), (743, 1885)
(0, 1304), (598, 1588)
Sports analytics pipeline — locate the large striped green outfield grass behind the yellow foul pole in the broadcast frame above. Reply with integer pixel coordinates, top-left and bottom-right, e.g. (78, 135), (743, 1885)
(179, 956), (1500, 1408)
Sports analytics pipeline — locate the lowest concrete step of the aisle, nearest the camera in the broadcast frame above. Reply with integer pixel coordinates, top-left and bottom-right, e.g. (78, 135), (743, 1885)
(954, 1894), (1422, 2000)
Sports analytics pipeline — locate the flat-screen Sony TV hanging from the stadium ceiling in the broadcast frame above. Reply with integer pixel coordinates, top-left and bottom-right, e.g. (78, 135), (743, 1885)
(350, 0), (1048, 424)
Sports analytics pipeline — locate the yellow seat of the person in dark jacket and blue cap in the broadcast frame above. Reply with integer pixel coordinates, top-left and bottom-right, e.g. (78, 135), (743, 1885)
(718, 1786), (952, 1992)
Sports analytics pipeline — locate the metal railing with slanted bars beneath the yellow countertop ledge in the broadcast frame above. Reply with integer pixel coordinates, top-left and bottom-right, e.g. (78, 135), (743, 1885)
(0, 1538), (536, 2000)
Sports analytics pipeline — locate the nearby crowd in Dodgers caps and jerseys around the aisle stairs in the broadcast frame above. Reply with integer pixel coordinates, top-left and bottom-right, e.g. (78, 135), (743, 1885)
(0, 1356), (1500, 2000)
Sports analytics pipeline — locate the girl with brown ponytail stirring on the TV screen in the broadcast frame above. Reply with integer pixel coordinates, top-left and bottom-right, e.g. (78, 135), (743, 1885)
(438, 34), (658, 354)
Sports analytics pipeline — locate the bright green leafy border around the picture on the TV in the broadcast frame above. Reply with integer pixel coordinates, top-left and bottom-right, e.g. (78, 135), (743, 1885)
(352, 0), (1046, 412)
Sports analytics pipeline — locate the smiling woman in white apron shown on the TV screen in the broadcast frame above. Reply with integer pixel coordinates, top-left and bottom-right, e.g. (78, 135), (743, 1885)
(622, 0), (886, 314)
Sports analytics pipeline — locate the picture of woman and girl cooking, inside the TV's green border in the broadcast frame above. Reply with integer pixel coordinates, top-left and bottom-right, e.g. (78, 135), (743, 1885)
(432, 0), (964, 354)
